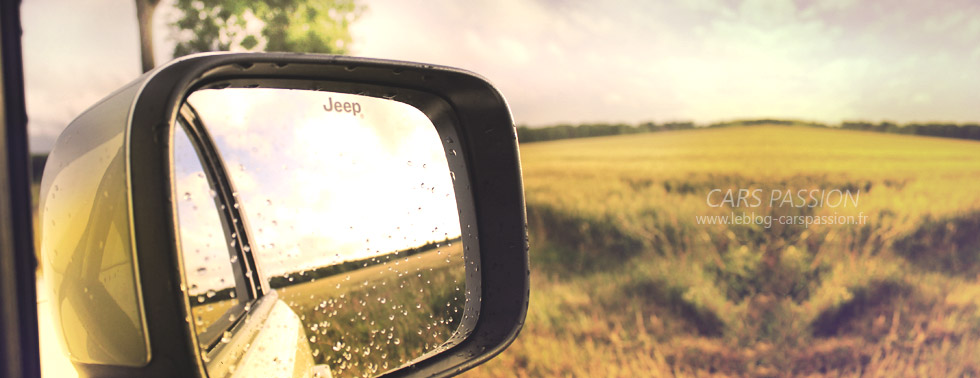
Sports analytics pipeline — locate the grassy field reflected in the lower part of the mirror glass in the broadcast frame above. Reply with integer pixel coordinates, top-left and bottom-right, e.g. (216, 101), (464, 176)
(278, 243), (466, 377)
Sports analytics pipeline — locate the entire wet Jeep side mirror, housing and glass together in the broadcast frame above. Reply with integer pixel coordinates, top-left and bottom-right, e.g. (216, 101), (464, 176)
(40, 53), (528, 377)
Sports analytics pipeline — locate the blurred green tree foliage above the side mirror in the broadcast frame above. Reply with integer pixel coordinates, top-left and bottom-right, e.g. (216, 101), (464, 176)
(172, 0), (364, 57)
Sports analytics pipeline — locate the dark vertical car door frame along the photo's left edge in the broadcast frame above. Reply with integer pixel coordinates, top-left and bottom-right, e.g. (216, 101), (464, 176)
(0, 1), (41, 378)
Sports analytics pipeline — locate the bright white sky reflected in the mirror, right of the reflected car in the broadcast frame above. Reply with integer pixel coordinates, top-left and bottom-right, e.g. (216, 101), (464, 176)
(185, 89), (460, 275)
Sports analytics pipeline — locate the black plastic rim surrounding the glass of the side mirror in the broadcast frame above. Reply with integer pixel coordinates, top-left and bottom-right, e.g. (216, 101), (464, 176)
(117, 53), (529, 377)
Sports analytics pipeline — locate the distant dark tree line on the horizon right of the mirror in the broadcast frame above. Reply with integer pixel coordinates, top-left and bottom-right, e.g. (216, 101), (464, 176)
(517, 119), (980, 143)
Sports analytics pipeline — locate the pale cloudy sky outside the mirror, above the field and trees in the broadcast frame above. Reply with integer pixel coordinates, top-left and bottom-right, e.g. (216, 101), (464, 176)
(22, 0), (980, 151)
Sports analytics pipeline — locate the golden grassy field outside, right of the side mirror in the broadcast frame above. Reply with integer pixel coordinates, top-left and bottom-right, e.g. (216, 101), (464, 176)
(466, 126), (980, 377)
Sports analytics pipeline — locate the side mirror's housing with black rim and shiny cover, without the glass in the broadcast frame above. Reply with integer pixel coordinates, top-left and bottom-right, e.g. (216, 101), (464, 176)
(41, 53), (529, 377)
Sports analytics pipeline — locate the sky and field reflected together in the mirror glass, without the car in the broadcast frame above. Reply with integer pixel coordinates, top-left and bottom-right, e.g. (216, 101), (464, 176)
(181, 88), (466, 377)
